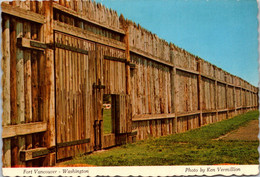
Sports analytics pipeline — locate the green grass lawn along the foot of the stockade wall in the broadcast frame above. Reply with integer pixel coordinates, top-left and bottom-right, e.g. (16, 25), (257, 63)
(66, 111), (259, 166)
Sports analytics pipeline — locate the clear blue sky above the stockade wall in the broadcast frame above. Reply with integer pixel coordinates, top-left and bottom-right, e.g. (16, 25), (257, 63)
(96, 0), (259, 86)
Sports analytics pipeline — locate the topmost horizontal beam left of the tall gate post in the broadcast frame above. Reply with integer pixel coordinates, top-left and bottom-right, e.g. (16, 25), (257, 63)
(1, 2), (46, 24)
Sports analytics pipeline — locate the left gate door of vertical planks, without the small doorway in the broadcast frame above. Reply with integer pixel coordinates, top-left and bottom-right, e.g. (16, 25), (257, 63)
(54, 32), (96, 160)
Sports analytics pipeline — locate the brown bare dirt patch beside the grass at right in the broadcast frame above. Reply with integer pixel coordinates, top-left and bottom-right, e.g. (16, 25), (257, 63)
(218, 120), (259, 141)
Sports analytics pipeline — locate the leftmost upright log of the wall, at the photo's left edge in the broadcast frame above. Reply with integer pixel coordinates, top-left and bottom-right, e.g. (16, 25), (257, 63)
(2, 16), (11, 167)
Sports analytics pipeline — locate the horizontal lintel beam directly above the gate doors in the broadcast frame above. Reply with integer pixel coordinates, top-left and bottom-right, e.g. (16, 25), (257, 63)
(53, 21), (126, 50)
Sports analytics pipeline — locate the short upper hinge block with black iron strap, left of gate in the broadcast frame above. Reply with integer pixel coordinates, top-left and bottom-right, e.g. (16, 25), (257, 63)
(17, 38), (49, 51)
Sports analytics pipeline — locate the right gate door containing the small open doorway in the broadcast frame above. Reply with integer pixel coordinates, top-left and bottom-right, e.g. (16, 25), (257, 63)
(99, 45), (127, 148)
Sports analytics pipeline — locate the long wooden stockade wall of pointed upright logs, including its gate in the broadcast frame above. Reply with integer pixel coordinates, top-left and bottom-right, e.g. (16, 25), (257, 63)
(1, 0), (258, 167)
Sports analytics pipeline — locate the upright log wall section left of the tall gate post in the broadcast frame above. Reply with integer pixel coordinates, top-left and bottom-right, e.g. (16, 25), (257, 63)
(2, 1), (46, 166)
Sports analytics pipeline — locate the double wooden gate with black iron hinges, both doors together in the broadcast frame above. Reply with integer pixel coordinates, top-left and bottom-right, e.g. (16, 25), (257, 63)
(54, 31), (126, 161)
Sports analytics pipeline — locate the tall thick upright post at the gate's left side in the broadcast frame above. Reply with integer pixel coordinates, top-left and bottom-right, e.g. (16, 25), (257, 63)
(42, 0), (56, 166)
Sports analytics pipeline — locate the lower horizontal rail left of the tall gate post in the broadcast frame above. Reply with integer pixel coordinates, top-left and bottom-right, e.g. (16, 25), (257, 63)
(2, 122), (47, 138)
